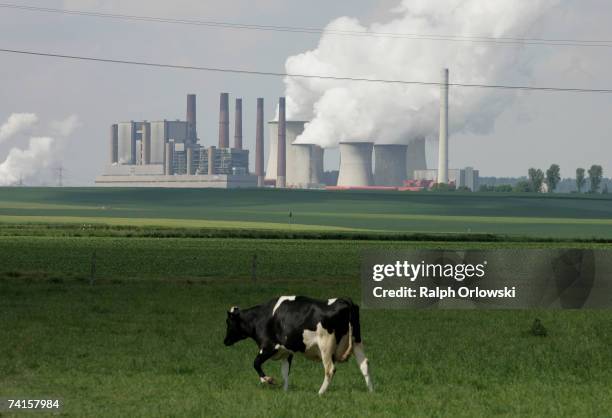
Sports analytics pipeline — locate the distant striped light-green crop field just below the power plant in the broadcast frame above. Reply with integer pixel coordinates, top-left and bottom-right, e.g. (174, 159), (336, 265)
(0, 188), (612, 239)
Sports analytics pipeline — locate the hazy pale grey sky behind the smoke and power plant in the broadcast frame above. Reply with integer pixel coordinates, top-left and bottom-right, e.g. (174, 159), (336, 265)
(0, 0), (612, 186)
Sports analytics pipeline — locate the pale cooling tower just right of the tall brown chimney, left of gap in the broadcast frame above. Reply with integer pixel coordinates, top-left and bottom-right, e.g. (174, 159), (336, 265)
(289, 144), (323, 189)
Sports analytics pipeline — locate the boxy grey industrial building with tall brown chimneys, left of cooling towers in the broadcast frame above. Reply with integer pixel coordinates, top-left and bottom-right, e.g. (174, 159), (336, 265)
(96, 93), (257, 188)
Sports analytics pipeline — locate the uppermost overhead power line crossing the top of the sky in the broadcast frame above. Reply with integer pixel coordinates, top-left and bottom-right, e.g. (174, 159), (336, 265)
(0, 3), (612, 48)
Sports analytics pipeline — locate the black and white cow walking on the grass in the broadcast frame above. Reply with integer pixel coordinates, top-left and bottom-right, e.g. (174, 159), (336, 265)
(224, 296), (373, 395)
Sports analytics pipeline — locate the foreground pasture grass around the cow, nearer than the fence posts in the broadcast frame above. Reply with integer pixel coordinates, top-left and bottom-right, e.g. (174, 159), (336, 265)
(0, 277), (612, 417)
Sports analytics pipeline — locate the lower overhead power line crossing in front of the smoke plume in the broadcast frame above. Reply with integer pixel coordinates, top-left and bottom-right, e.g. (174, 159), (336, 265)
(0, 48), (612, 94)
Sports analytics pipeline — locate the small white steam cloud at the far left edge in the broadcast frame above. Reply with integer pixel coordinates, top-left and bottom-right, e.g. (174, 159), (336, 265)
(0, 113), (79, 186)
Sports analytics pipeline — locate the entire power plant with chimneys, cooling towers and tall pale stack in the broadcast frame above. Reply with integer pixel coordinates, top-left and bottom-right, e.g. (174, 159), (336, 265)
(96, 69), (478, 190)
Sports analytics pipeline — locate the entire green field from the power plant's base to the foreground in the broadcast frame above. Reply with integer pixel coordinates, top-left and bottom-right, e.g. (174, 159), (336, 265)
(0, 189), (612, 417)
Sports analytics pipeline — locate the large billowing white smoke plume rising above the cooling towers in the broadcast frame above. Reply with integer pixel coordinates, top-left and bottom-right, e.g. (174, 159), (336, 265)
(285, 0), (559, 147)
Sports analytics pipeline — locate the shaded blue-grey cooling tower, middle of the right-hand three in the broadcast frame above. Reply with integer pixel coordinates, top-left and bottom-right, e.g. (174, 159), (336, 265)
(374, 144), (408, 186)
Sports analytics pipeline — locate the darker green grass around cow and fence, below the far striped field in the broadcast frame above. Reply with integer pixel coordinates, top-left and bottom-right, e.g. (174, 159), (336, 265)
(0, 236), (612, 417)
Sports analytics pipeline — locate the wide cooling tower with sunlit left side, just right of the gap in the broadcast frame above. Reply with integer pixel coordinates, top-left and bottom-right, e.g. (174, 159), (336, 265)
(338, 142), (374, 187)
